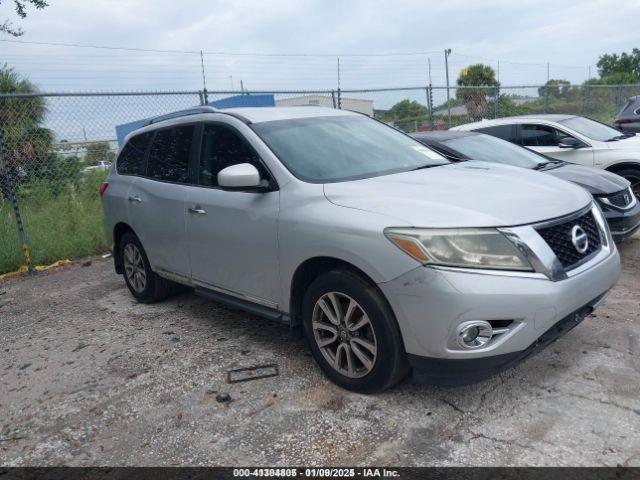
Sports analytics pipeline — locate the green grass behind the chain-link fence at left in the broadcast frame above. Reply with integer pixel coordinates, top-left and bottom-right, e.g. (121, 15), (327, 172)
(0, 172), (108, 274)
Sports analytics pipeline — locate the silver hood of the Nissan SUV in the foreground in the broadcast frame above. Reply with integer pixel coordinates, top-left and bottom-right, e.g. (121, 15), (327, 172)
(324, 160), (591, 228)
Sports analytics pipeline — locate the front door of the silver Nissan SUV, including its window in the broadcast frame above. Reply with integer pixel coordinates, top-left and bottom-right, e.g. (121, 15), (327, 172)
(186, 123), (280, 308)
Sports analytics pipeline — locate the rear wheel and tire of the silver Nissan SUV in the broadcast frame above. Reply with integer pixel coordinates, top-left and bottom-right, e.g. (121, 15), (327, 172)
(120, 232), (169, 303)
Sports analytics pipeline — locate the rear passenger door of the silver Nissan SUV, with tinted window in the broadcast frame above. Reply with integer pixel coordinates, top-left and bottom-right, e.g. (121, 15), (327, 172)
(127, 124), (195, 278)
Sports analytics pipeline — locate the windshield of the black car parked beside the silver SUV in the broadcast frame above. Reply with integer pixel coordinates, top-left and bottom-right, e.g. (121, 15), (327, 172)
(442, 134), (548, 168)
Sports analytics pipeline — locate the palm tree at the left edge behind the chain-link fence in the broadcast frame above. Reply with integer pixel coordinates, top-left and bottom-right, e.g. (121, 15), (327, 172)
(0, 64), (53, 194)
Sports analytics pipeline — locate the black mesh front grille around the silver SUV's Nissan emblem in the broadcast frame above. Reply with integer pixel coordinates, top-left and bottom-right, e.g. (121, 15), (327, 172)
(538, 211), (602, 270)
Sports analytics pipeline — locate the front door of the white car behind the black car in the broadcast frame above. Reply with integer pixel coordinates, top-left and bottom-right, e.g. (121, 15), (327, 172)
(518, 123), (594, 167)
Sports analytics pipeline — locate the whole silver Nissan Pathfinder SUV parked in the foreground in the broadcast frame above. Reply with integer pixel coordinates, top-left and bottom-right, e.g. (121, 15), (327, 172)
(101, 107), (620, 392)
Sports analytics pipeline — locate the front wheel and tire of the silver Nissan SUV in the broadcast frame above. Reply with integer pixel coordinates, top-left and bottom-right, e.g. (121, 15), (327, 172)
(302, 269), (409, 393)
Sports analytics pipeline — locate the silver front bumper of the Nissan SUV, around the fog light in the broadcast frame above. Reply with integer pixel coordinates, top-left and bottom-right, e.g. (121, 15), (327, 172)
(379, 246), (620, 379)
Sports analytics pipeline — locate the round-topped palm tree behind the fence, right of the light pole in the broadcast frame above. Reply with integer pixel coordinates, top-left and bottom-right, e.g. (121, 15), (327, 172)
(456, 63), (500, 120)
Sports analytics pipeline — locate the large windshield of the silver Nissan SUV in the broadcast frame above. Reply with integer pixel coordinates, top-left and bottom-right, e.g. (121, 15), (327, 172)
(251, 115), (449, 183)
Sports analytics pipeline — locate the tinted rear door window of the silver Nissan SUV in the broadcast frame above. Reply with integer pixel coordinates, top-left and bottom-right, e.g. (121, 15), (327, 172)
(147, 125), (195, 183)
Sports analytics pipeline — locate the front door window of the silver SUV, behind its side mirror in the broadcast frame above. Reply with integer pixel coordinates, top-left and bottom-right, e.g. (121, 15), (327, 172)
(199, 124), (268, 187)
